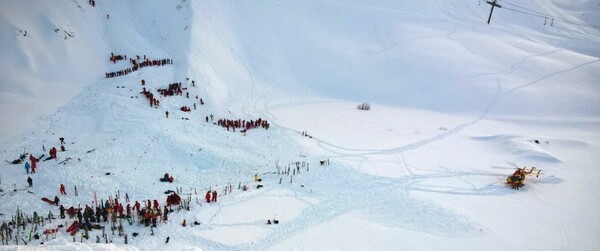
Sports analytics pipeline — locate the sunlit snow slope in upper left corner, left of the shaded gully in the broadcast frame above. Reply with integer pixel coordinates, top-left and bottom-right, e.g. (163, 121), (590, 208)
(0, 1), (108, 141)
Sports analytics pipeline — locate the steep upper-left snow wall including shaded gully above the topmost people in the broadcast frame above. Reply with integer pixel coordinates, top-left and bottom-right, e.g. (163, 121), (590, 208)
(0, 0), (191, 141)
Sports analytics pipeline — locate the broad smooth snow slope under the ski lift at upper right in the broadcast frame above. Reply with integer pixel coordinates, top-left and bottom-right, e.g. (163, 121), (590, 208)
(190, 1), (600, 116)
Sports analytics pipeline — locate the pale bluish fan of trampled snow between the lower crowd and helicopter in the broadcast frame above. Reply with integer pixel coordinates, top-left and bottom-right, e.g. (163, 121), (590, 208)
(237, 167), (483, 250)
